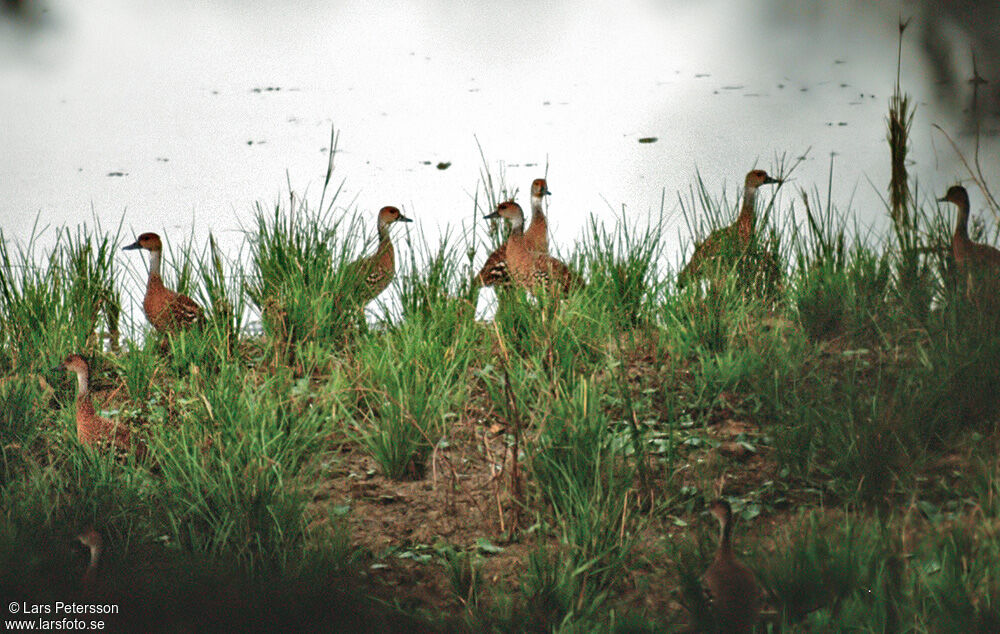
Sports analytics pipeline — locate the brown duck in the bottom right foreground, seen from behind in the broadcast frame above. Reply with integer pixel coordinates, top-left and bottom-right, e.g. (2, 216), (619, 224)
(702, 499), (761, 632)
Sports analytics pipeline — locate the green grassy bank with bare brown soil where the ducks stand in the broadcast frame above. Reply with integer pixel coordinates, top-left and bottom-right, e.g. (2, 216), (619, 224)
(0, 60), (1000, 632)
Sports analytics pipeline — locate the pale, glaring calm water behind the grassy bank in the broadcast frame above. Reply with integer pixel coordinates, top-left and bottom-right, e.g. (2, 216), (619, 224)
(0, 0), (1000, 314)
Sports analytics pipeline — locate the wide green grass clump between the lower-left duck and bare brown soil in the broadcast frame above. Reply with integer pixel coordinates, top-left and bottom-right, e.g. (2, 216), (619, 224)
(153, 364), (325, 569)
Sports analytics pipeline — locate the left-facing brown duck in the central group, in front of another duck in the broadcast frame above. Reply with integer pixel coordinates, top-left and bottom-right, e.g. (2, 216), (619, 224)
(486, 201), (585, 293)
